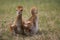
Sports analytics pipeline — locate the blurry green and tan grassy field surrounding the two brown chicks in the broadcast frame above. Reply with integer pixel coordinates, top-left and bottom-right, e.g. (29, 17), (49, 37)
(0, 0), (60, 40)
